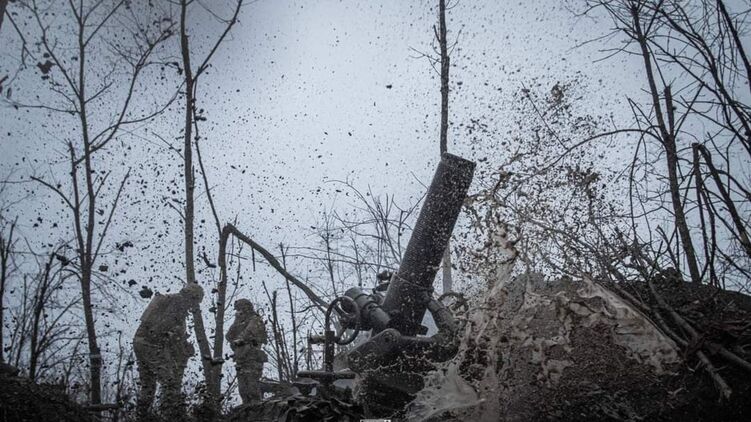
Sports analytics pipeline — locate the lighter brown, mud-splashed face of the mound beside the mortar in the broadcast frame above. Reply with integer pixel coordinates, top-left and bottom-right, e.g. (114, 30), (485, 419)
(407, 274), (680, 421)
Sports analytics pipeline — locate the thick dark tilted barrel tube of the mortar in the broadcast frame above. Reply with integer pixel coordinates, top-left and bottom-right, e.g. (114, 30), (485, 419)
(381, 153), (475, 336)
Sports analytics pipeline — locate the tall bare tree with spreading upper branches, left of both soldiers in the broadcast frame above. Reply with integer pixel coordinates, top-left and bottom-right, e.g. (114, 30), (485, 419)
(7, 0), (173, 404)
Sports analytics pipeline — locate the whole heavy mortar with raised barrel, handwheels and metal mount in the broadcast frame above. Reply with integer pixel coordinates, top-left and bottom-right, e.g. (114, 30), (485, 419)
(298, 154), (475, 416)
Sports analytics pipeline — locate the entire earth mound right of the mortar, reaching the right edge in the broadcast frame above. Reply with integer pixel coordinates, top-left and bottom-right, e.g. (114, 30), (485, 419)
(408, 275), (751, 421)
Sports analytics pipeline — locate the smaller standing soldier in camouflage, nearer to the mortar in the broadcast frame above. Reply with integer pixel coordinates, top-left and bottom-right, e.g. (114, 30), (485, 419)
(227, 299), (268, 404)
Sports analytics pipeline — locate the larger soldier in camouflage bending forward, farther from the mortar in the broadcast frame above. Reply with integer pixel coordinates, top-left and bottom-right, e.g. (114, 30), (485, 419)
(133, 283), (203, 419)
